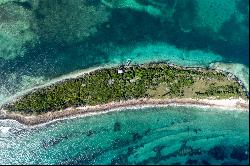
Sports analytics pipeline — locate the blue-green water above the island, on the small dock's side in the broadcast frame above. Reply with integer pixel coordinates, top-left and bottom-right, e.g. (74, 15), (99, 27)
(0, 0), (249, 104)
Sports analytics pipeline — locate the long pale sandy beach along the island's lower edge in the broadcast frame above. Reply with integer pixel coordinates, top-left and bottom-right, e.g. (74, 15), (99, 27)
(0, 98), (249, 126)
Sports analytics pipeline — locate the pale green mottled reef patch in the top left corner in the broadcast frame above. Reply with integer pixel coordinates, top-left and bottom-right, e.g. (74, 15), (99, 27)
(0, 0), (38, 59)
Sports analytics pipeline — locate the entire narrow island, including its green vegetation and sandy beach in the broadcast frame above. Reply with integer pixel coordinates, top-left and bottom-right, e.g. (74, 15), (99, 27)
(0, 62), (248, 125)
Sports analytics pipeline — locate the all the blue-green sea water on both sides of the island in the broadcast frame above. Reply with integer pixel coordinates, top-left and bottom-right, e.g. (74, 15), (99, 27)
(0, 0), (249, 164)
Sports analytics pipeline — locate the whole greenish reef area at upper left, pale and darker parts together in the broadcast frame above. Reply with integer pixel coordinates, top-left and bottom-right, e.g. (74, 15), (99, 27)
(0, 0), (109, 59)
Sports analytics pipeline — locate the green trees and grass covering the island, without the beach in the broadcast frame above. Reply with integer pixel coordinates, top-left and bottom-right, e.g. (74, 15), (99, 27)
(3, 64), (246, 114)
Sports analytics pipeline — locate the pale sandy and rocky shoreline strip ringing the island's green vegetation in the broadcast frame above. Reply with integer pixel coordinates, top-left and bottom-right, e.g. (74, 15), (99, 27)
(0, 61), (249, 126)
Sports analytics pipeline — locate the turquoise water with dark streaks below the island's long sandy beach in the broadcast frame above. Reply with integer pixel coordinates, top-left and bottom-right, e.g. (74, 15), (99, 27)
(0, 106), (249, 164)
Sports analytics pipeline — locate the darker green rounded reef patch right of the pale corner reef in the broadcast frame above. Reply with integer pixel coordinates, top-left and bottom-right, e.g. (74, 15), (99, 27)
(35, 0), (109, 45)
